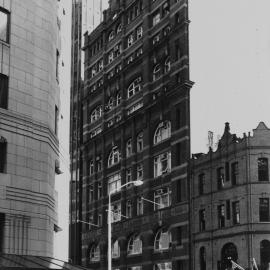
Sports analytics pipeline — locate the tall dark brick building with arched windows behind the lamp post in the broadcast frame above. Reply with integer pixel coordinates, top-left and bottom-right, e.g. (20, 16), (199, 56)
(70, 0), (192, 270)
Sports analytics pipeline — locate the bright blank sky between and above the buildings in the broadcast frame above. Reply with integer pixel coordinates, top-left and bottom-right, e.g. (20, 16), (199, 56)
(55, 0), (270, 260)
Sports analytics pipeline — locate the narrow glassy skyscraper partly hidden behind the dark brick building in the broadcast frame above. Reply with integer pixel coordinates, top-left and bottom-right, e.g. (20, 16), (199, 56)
(69, 0), (106, 264)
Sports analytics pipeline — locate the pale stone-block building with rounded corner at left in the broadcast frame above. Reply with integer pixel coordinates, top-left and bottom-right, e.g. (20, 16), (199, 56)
(0, 0), (60, 256)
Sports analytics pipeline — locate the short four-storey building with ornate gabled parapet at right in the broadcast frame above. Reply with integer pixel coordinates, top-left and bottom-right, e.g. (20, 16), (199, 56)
(191, 122), (270, 270)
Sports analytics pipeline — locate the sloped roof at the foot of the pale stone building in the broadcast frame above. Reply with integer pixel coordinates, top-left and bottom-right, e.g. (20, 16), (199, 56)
(0, 253), (86, 270)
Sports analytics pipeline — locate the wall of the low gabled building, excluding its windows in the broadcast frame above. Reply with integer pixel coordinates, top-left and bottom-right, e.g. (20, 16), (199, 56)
(191, 123), (270, 270)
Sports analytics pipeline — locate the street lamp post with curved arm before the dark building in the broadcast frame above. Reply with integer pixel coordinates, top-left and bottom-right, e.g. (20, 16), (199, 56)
(108, 180), (143, 270)
